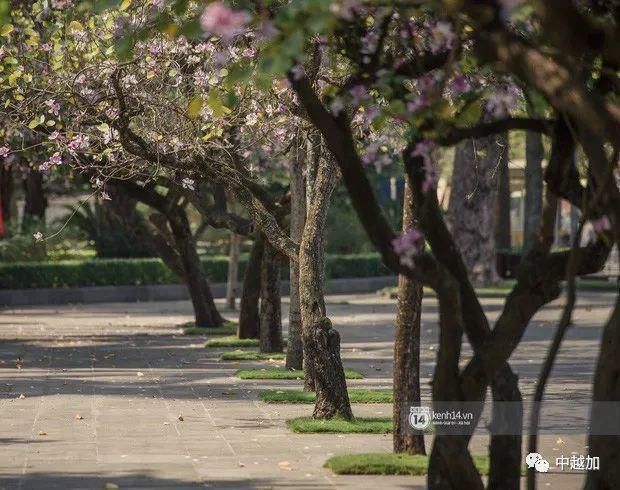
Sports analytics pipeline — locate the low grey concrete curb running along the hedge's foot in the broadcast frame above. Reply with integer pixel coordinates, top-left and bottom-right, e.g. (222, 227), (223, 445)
(0, 276), (397, 308)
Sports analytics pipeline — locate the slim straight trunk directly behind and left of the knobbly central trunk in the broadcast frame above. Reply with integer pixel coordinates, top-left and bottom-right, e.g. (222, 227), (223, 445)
(286, 130), (306, 369)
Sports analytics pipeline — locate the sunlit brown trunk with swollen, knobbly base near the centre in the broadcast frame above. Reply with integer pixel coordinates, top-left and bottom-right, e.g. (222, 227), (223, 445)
(299, 158), (353, 419)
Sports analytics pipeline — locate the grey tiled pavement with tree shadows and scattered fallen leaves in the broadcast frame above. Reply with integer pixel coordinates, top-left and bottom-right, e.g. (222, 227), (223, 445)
(0, 294), (613, 490)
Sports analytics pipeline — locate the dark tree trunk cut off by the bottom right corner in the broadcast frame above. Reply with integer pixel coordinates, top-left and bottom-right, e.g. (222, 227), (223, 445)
(585, 295), (620, 490)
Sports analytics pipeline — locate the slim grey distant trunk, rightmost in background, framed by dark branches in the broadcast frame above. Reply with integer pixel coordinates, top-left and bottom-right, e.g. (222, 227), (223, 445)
(523, 126), (544, 253)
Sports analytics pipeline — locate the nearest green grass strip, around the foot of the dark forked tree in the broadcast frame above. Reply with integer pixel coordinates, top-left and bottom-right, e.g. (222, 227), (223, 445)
(324, 453), (526, 476)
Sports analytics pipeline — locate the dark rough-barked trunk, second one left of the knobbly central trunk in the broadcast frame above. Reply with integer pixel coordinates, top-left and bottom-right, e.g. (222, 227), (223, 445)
(260, 243), (284, 352)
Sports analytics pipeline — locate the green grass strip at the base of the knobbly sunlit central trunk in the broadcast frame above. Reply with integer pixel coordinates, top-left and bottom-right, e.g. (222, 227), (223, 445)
(286, 417), (392, 434)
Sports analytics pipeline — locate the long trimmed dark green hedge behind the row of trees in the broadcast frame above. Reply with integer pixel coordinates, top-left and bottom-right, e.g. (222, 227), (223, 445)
(0, 254), (391, 289)
